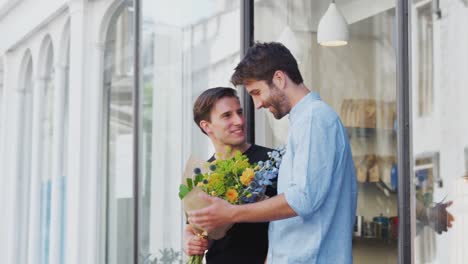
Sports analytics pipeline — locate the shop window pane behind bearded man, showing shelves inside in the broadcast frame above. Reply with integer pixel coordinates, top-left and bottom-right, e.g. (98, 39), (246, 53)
(254, 0), (398, 263)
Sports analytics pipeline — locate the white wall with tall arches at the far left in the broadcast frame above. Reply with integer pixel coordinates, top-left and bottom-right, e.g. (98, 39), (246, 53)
(0, 0), (122, 264)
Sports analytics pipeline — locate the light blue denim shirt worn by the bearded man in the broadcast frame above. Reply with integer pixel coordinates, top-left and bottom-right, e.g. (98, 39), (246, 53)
(268, 92), (357, 264)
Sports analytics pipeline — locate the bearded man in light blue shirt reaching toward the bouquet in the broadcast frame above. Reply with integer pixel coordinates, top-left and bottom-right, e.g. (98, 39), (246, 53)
(188, 42), (357, 264)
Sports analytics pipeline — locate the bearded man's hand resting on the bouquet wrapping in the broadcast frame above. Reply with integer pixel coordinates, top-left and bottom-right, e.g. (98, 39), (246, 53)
(187, 195), (235, 234)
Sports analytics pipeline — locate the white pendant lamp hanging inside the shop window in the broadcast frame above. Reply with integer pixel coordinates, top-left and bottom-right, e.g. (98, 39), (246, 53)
(317, 0), (349, 47)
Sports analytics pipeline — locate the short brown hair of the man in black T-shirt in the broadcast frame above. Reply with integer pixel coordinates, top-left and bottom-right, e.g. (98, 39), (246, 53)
(193, 87), (239, 134)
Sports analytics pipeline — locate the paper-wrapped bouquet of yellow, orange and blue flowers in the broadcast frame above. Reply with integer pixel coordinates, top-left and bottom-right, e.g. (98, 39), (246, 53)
(179, 148), (285, 264)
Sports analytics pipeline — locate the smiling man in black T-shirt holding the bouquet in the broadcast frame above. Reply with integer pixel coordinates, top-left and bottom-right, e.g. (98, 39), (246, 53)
(184, 87), (276, 264)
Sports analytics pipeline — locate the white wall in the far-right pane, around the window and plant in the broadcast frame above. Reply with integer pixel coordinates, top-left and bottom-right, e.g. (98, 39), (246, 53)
(412, 0), (468, 263)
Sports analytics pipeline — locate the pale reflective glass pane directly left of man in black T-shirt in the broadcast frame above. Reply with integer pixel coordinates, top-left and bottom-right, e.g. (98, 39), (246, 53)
(138, 0), (240, 263)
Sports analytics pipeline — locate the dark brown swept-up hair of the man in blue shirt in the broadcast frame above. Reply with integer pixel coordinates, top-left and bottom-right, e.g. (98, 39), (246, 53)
(231, 42), (304, 85)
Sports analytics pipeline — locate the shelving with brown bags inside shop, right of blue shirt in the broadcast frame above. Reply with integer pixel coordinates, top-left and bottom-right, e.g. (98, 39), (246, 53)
(341, 99), (398, 263)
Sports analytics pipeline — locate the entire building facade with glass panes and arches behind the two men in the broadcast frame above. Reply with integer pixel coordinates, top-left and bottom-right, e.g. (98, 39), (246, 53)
(0, 0), (468, 264)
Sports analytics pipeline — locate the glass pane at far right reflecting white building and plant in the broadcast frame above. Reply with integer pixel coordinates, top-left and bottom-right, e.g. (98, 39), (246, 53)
(410, 0), (468, 263)
